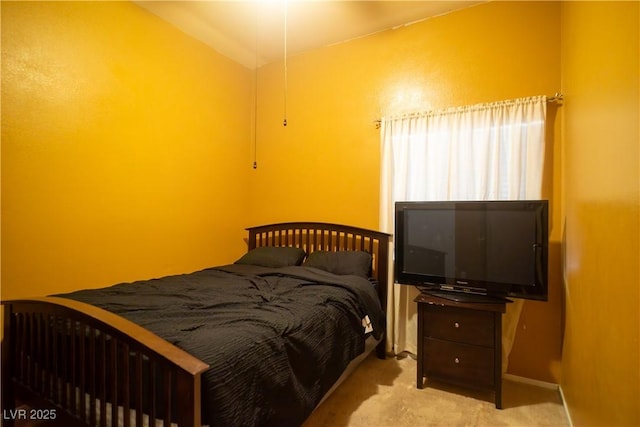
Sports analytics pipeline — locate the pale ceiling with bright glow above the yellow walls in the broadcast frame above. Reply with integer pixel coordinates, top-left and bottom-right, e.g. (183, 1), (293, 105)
(134, 0), (482, 68)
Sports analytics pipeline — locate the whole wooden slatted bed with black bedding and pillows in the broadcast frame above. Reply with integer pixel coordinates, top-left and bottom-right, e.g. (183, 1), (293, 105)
(2, 222), (390, 427)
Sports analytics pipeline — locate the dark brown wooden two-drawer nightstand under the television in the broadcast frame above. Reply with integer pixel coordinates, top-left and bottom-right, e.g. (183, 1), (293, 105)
(415, 293), (506, 409)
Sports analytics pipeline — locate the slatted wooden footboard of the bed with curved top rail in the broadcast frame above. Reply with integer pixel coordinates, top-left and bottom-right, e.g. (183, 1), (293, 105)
(2, 297), (208, 427)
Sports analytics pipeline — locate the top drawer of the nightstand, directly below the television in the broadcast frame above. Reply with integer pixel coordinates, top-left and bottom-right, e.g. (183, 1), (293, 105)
(422, 306), (494, 347)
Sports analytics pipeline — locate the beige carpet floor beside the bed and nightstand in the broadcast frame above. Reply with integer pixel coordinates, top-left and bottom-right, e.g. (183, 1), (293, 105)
(303, 355), (570, 427)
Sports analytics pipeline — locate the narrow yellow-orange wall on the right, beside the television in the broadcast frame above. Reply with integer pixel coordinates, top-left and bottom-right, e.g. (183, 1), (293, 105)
(562, 2), (640, 426)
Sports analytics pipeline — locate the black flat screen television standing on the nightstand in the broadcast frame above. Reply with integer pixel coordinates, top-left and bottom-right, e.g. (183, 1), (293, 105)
(394, 200), (549, 302)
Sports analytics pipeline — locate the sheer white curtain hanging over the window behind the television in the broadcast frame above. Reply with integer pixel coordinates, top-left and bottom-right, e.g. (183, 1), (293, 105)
(380, 96), (547, 369)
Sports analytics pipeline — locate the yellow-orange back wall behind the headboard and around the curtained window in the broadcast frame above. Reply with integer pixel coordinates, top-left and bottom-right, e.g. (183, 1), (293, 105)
(249, 2), (562, 382)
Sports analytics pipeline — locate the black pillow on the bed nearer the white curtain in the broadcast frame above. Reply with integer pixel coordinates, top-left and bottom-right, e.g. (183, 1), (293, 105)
(304, 251), (372, 278)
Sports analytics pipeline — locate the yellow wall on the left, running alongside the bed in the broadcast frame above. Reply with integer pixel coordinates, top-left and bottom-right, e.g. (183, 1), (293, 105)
(2, 1), (252, 299)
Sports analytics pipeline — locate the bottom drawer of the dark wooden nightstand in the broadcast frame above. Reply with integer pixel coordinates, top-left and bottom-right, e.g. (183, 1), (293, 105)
(423, 338), (495, 388)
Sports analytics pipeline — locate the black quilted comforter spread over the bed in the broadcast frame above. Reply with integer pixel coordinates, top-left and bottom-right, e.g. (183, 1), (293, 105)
(58, 264), (385, 426)
